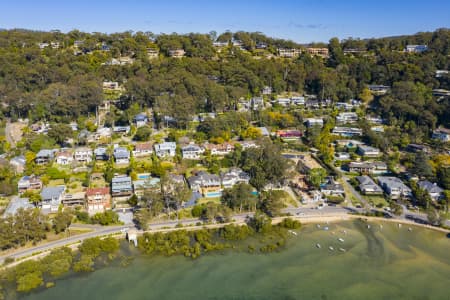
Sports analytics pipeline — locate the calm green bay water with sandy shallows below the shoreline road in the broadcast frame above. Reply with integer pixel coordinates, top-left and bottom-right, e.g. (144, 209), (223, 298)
(21, 221), (450, 300)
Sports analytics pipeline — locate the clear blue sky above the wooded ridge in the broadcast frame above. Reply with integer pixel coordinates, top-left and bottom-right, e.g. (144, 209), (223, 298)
(0, 0), (450, 43)
